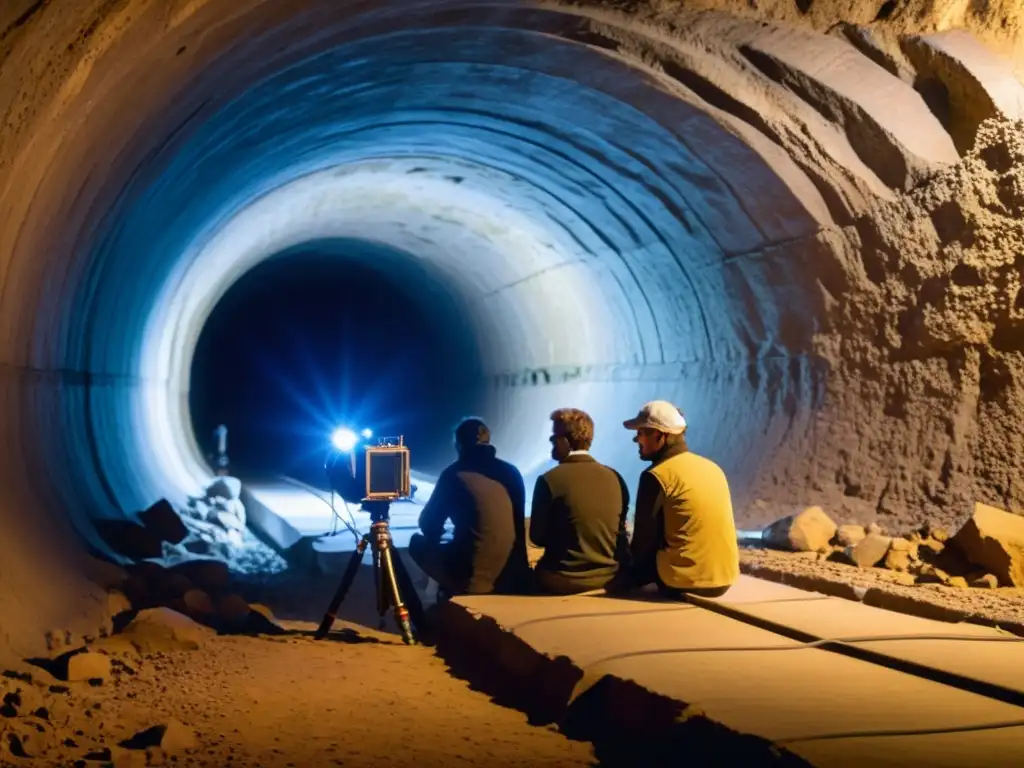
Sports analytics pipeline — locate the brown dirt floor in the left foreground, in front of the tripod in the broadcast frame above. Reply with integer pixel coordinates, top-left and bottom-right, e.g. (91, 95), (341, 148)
(0, 623), (594, 767)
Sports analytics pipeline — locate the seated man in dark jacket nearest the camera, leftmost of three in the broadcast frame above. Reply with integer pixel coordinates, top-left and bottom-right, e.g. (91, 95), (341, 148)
(409, 419), (529, 595)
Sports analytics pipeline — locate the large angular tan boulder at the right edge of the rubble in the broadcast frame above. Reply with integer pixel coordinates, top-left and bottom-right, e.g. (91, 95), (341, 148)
(949, 503), (1024, 587)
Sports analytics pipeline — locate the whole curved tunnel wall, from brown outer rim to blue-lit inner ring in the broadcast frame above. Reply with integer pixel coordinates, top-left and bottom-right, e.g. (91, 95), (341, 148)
(0, 0), (1013, 663)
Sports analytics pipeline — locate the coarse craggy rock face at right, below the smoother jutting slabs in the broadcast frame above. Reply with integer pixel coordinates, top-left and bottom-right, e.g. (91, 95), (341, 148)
(764, 121), (1024, 527)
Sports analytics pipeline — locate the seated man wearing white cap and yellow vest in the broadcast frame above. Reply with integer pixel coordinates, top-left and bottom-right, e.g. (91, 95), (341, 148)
(621, 400), (739, 597)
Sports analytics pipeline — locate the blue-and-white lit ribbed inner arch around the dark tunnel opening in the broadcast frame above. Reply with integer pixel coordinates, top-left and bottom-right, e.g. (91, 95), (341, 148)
(8, 4), (823, 536)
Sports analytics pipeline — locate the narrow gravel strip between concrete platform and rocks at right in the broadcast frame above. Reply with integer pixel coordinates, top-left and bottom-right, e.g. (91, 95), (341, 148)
(740, 547), (1024, 635)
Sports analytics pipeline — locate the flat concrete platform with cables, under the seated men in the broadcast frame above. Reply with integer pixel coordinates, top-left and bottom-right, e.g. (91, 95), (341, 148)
(446, 578), (1024, 766)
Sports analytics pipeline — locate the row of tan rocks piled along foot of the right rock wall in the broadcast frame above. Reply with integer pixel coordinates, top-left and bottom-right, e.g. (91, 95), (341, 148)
(762, 504), (1024, 589)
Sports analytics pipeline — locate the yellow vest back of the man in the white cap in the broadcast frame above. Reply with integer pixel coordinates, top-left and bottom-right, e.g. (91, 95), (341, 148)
(646, 451), (739, 589)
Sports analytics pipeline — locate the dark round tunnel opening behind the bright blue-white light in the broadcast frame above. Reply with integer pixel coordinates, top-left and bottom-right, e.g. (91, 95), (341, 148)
(189, 240), (484, 486)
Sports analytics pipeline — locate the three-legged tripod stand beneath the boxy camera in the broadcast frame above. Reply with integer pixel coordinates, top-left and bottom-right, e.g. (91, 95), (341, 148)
(315, 501), (424, 645)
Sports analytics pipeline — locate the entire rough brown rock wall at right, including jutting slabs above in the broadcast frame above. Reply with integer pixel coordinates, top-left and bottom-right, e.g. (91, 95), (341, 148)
(552, 0), (1024, 528)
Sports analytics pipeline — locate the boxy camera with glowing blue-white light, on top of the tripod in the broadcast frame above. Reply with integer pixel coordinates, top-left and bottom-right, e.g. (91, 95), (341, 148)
(325, 429), (412, 513)
